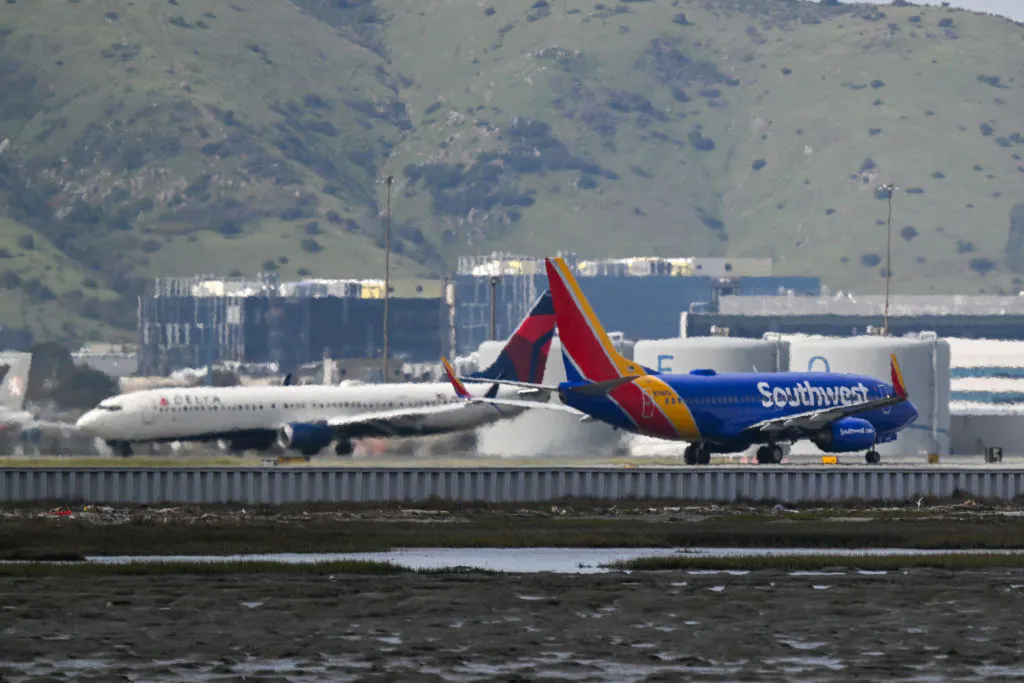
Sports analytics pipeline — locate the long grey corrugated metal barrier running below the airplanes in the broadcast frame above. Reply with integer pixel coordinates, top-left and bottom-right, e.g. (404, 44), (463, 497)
(0, 466), (1024, 505)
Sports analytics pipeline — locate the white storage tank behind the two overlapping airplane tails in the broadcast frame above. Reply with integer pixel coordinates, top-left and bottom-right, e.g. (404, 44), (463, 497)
(476, 337), (629, 457)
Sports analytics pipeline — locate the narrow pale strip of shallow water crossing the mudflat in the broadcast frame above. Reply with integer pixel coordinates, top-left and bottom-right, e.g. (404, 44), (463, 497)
(86, 548), (1024, 573)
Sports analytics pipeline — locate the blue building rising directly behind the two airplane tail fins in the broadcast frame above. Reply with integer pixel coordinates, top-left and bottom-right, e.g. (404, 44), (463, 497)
(453, 253), (821, 354)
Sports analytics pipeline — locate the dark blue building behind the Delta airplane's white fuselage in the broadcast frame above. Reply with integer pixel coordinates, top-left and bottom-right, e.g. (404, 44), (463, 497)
(137, 274), (449, 375)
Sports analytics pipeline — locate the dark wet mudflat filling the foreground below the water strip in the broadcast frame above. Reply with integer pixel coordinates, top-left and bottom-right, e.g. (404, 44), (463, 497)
(0, 569), (1024, 682)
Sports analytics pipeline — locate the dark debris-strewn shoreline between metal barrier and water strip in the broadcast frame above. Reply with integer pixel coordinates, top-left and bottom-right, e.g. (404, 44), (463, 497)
(0, 502), (1024, 560)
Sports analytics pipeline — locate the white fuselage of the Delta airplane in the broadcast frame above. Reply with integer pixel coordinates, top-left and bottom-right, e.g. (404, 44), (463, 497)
(78, 383), (522, 441)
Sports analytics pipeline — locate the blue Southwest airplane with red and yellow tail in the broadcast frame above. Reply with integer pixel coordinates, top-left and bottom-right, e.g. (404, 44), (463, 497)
(454, 258), (918, 465)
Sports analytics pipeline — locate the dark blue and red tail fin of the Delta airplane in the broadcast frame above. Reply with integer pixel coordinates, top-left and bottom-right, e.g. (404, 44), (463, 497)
(469, 291), (555, 384)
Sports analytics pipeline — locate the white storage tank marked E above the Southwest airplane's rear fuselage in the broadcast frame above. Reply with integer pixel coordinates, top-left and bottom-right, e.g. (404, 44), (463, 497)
(633, 337), (790, 374)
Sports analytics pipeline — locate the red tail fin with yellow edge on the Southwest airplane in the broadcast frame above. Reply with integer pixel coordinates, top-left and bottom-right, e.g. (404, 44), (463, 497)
(546, 258), (650, 382)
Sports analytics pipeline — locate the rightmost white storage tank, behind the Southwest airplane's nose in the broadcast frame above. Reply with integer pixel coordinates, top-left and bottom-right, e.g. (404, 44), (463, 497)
(790, 333), (950, 456)
